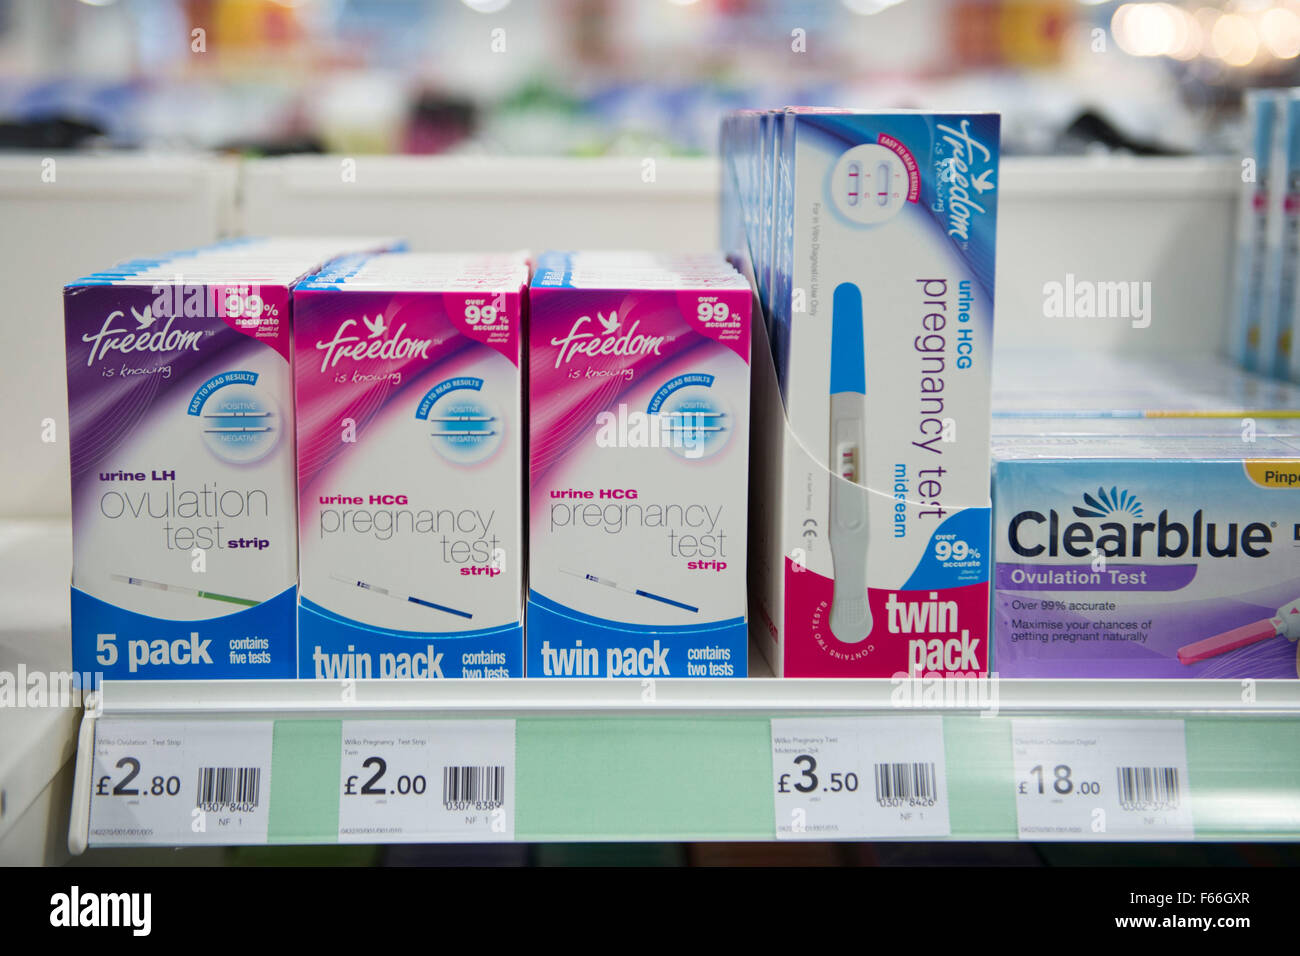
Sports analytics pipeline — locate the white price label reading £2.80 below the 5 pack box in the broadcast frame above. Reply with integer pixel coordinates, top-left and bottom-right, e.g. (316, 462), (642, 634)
(90, 718), (273, 845)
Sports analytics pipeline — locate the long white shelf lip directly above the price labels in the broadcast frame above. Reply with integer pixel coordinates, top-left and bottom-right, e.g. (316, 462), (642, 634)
(91, 678), (1300, 717)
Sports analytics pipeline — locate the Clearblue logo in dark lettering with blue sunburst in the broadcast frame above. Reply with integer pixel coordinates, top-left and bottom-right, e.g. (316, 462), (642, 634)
(1006, 488), (1273, 558)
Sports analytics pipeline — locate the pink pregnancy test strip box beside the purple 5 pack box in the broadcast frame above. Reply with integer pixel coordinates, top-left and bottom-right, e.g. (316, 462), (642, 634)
(294, 252), (528, 679)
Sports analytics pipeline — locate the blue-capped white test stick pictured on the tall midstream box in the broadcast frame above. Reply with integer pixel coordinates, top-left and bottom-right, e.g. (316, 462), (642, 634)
(829, 282), (871, 644)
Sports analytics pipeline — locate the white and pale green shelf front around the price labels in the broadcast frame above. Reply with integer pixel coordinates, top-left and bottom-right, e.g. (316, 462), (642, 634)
(69, 679), (1300, 851)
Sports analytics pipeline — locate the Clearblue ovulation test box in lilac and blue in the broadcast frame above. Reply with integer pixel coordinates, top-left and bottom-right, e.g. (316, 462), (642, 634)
(993, 436), (1300, 679)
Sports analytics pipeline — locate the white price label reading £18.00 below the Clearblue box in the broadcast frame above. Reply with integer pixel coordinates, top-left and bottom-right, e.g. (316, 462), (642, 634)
(1011, 718), (1195, 840)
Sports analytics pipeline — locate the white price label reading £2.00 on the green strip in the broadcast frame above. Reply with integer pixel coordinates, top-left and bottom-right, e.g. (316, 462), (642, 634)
(338, 721), (515, 843)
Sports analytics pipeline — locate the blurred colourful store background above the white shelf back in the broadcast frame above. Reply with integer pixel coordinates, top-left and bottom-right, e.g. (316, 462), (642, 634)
(0, 0), (1300, 156)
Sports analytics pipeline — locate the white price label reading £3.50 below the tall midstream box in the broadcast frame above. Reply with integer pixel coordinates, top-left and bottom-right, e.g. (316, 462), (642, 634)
(772, 717), (949, 840)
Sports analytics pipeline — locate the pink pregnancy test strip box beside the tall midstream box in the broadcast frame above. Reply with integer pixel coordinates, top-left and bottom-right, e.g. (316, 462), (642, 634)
(528, 252), (751, 678)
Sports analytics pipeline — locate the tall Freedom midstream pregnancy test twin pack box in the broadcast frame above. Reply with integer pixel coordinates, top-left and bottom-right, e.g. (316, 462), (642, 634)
(751, 109), (998, 678)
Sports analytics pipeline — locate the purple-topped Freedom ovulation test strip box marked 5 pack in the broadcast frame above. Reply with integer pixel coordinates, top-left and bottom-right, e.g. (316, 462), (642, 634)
(64, 238), (393, 679)
